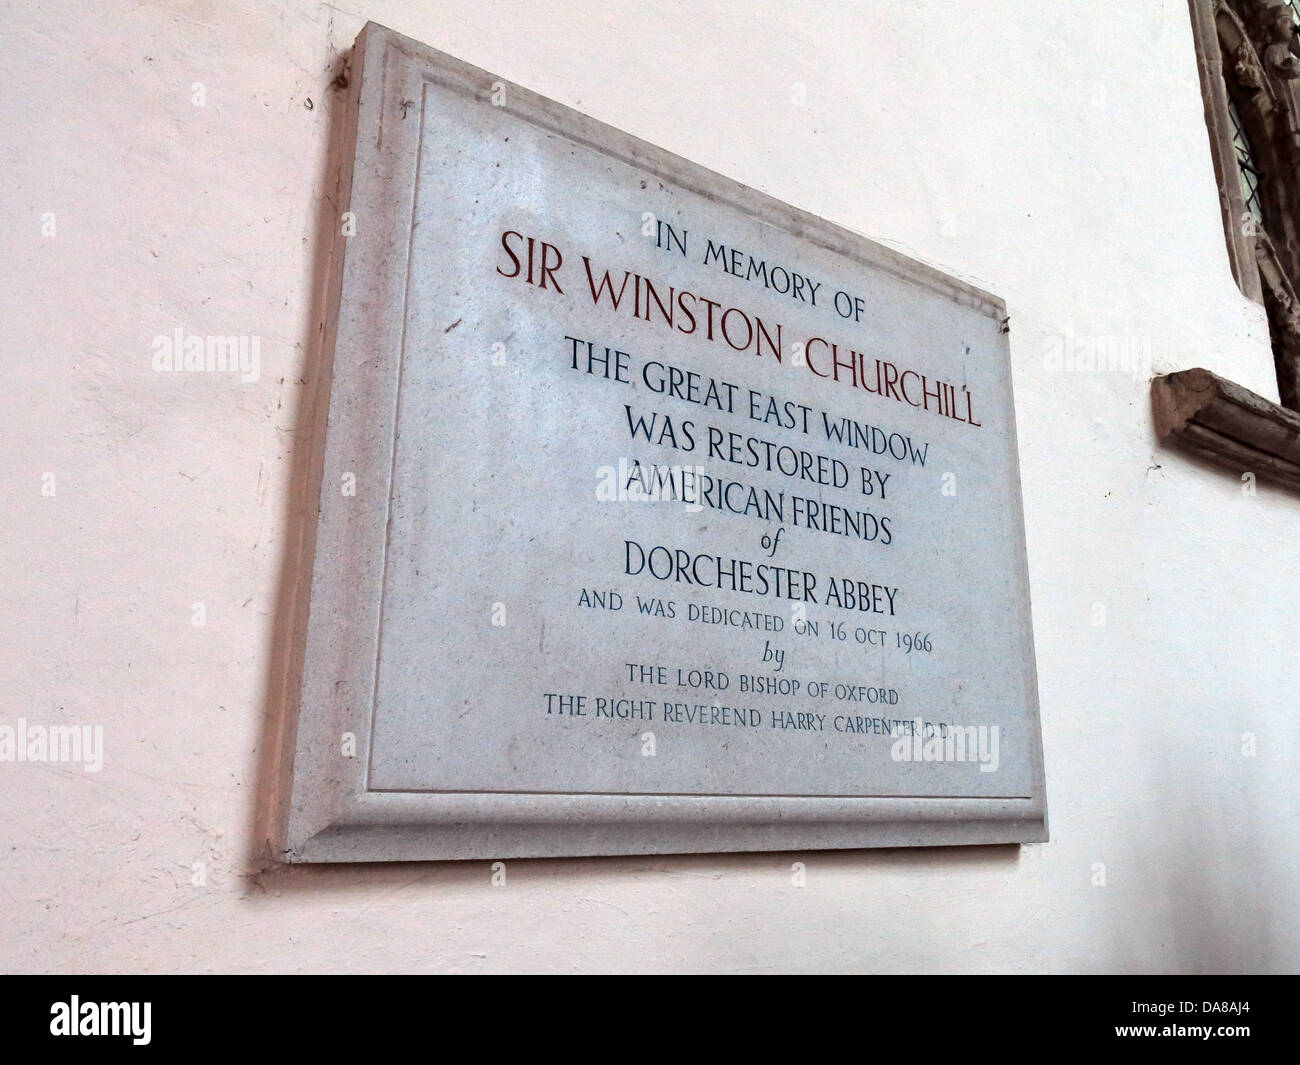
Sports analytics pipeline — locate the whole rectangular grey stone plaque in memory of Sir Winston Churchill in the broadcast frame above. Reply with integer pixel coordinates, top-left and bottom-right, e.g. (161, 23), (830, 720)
(283, 23), (1047, 861)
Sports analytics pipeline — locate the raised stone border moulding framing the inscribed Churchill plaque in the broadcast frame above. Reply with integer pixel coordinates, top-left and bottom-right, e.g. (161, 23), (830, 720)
(274, 22), (1048, 862)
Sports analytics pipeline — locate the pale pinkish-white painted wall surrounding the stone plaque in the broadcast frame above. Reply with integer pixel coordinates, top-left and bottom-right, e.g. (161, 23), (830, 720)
(0, 0), (1300, 971)
